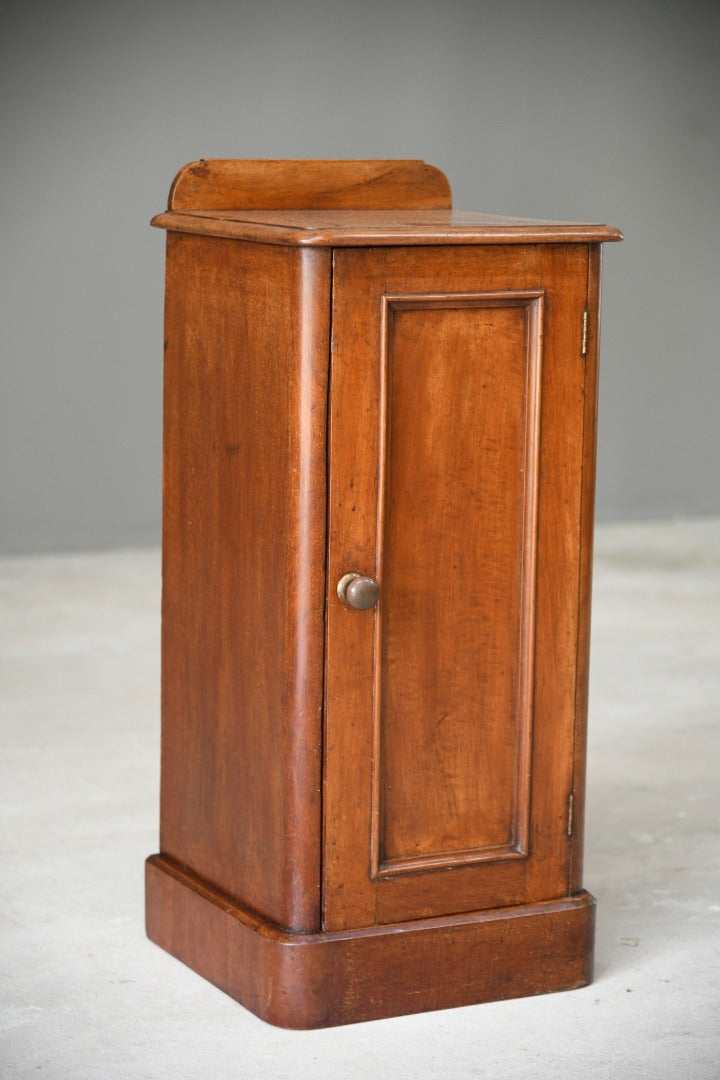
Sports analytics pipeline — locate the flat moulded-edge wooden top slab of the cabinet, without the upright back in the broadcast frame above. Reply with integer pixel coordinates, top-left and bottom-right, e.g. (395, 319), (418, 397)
(152, 208), (622, 247)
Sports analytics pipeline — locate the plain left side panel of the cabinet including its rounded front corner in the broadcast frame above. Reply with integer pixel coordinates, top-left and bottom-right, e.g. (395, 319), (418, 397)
(161, 233), (329, 930)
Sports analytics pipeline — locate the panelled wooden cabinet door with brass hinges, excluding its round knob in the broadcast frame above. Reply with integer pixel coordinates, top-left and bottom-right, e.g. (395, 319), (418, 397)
(323, 244), (593, 930)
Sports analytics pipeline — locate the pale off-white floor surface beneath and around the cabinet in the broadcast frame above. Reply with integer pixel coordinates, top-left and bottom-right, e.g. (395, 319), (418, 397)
(0, 521), (720, 1080)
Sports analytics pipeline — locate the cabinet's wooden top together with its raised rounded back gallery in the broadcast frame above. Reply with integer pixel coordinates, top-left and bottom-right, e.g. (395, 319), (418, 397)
(152, 159), (622, 247)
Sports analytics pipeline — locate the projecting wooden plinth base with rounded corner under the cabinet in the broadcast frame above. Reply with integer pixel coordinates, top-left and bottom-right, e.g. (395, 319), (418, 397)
(146, 855), (595, 1028)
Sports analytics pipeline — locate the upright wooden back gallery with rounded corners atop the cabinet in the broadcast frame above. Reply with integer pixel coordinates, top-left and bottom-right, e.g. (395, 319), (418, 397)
(167, 158), (451, 211)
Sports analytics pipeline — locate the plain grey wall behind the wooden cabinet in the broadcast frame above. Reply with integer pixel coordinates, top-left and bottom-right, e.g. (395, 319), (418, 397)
(0, 0), (720, 552)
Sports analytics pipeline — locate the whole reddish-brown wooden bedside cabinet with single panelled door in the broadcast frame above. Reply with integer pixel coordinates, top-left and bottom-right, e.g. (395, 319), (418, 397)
(147, 161), (620, 1027)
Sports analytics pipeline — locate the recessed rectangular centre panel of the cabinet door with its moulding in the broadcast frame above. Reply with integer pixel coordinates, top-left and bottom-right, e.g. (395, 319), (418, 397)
(375, 293), (542, 873)
